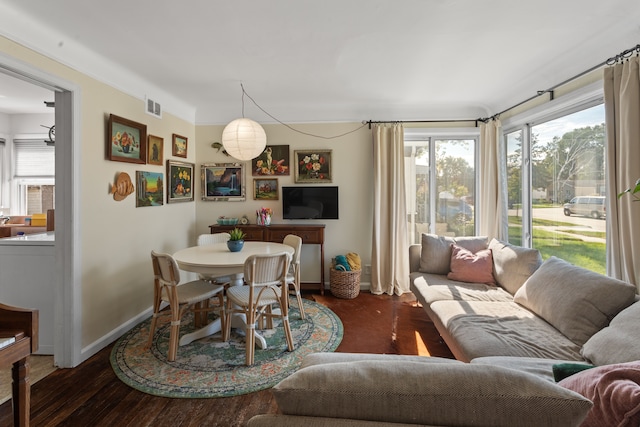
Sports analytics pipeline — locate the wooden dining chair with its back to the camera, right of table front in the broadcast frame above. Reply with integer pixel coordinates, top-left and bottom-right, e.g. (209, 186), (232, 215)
(222, 252), (293, 366)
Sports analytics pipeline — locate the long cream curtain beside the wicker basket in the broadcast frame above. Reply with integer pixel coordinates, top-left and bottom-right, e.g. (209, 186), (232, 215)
(371, 124), (410, 295)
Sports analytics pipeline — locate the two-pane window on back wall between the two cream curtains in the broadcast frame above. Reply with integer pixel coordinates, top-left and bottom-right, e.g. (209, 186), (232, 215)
(405, 129), (477, 243)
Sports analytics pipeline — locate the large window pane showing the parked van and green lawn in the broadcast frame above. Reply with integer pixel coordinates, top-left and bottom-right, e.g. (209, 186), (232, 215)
(528, 104), (606, 274)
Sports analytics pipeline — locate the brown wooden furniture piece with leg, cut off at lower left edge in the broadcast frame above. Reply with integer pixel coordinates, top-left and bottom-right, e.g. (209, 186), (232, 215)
(0, 304), (38, 427)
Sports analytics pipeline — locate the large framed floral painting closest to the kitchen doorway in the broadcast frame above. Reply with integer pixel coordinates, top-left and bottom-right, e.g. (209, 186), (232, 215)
(107, 114), (147, 164)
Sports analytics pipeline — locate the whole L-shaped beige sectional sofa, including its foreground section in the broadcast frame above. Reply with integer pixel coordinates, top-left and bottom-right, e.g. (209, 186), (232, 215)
(248, 239), (640, 427)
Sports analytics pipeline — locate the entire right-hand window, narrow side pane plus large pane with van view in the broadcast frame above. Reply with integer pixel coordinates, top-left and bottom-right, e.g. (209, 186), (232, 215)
(505, 103), (606, 274)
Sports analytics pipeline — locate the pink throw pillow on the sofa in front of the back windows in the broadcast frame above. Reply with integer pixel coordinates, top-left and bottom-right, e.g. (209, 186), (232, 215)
(447, 244), (496, 285)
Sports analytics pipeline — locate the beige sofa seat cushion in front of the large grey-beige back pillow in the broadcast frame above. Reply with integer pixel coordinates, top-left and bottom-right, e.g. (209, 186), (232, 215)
(429, 301), (583, 361)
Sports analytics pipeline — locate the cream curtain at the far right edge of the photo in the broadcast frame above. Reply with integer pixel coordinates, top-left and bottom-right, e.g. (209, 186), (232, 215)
(604, 57), (640, 289)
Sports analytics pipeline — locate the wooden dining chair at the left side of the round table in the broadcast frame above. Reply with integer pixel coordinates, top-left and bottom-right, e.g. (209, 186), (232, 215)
(147, 251), (225, 362)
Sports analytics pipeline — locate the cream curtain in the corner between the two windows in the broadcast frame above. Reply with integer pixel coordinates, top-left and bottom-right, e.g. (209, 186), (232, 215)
(476, 119), (509, 241)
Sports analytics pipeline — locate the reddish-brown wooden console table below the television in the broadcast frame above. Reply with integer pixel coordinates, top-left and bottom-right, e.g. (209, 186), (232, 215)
(209, 224), (325, 295)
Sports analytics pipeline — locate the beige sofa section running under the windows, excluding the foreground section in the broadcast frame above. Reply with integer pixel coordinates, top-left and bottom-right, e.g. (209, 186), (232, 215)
(410, 234), (640, 365)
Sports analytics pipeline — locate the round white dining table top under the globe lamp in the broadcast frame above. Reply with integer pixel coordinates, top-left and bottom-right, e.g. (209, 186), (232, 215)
(173, 242), (295, 274)
